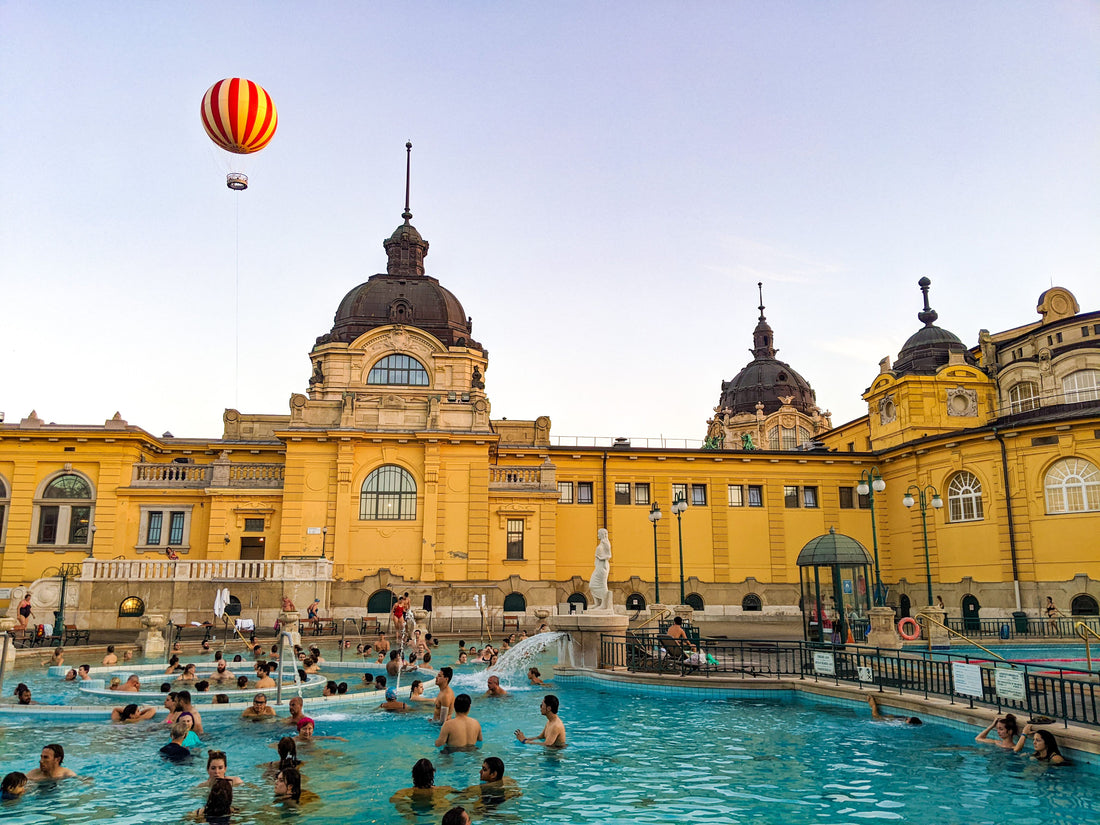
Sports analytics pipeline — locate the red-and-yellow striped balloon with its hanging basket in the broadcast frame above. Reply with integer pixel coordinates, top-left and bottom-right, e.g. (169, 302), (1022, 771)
(200, 77), (278, 189)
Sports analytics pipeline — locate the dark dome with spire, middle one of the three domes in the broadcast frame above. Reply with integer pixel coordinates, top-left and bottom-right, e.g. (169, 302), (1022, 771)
(718, 288), (817, 416)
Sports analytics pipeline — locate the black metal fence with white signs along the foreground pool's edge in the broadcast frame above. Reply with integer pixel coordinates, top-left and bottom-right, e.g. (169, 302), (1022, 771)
(600, 631), (1100, 727)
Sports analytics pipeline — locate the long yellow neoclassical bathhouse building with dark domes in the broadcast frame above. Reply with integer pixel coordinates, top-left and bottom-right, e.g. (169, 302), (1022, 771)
(0, 203), (1100, 627)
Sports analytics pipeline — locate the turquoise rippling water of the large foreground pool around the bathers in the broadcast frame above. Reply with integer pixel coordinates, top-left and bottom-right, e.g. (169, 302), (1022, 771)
(0, 659), (1100, 825)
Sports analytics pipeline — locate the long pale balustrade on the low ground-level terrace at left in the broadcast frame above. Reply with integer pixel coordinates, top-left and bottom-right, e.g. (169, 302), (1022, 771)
(80, 559), (332, 582)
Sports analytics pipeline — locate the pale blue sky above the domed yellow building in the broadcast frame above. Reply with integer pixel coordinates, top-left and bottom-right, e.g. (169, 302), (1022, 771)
(0, 0), (1100, 438)
